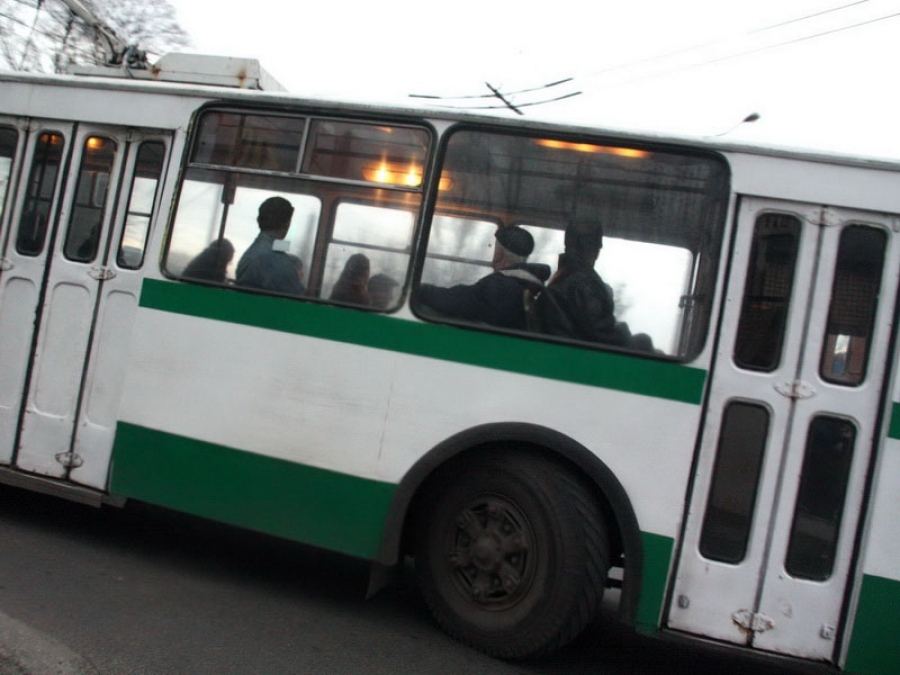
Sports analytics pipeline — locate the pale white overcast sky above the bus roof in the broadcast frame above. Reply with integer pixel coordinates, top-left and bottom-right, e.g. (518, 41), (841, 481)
(172, 0), (900, 159)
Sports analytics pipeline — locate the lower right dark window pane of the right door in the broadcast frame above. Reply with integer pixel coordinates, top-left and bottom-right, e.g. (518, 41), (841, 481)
(784, 415), (856, 581)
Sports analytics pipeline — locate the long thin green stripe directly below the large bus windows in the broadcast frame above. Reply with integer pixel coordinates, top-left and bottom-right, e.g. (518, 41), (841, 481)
(141, 279), (706, 404)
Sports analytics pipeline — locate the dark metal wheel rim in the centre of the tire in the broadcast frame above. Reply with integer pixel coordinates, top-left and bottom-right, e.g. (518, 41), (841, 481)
(445, 495), (536, 611)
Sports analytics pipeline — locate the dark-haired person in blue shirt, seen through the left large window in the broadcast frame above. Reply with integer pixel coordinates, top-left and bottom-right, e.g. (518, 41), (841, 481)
(235, 197), (306, 295)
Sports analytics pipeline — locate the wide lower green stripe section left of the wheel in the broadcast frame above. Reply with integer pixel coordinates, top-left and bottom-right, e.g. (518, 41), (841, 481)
(110, 422), (396, 558)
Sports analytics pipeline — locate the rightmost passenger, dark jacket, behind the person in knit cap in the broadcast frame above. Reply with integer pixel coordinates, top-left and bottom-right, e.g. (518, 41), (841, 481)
(535, 223), (631, 347)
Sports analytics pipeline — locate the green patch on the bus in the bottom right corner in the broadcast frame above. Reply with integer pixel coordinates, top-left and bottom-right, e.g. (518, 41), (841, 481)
(845, 575), (900, 675)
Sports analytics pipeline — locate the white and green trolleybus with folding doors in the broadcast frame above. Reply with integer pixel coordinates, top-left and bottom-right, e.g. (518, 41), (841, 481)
(0, 54), (900, 675)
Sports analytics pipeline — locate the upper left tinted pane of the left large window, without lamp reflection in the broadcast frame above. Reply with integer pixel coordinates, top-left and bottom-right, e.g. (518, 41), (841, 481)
(191, 112), (306, 172)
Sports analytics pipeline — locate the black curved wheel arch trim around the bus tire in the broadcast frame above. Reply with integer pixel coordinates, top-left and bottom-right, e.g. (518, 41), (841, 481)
(370, 422), (643, 625)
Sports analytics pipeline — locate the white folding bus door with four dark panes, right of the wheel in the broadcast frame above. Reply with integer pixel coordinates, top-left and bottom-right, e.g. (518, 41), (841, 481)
(667, 199), (900, 661)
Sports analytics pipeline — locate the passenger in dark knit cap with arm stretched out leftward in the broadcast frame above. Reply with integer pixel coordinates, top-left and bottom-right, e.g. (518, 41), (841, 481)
(418, 226), (550, 330)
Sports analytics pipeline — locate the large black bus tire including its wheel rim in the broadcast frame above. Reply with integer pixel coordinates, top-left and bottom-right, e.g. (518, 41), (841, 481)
(416, 452), (609, 659)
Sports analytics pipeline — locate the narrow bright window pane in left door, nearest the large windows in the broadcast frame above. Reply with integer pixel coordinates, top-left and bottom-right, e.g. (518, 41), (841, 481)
(116, 141), (166, 269)
